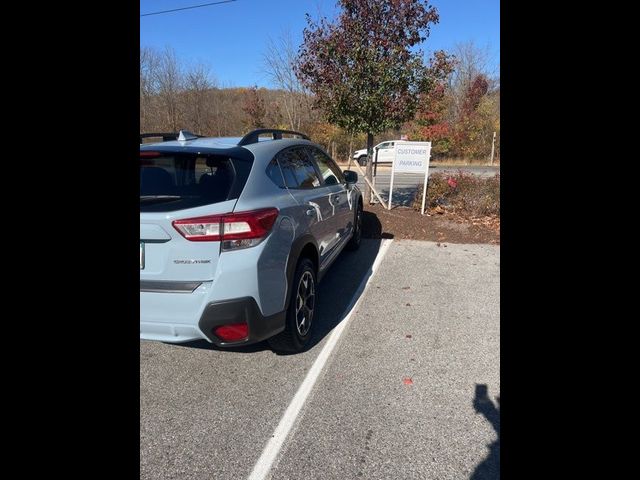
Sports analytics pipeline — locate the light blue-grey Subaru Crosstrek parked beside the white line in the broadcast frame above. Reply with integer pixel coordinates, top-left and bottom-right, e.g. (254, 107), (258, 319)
(140, 129), (363, 352)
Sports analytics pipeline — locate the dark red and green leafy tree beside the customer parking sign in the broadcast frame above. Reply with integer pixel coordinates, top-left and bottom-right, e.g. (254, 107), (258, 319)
(296, 0), (450, 200)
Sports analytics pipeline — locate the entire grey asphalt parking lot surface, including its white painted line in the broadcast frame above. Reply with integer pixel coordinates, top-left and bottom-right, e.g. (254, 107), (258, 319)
(140, 240), (500, 480)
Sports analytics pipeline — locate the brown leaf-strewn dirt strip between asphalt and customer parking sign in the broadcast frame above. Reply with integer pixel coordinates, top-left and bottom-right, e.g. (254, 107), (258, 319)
(362, 204), (500, 245)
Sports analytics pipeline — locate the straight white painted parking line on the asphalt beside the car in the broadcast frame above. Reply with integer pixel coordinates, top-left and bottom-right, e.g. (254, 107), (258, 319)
(249, 239), (393, 480)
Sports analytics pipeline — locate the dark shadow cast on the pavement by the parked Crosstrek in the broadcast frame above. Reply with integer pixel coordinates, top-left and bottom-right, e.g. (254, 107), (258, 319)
(178, 211), (393, 355)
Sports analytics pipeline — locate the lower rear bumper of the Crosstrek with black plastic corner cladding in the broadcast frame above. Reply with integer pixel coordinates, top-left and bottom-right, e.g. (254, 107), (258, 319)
(140, 294), (286, 347)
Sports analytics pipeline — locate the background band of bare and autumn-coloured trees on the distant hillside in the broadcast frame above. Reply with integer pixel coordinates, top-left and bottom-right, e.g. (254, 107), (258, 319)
(140, 36), (500, 165)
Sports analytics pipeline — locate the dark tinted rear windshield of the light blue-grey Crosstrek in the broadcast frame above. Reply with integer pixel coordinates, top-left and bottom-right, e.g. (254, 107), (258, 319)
(140, 151), (251, 212)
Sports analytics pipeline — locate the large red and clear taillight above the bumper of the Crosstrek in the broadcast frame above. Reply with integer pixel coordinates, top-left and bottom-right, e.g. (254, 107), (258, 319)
(172, 208), (278, 250)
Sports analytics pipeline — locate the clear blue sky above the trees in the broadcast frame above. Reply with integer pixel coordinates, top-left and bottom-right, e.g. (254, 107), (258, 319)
(140, 0), (500, 87)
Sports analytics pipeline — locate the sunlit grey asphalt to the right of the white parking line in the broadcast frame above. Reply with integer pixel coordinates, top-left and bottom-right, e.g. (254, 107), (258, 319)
(273, 240), (500, 480)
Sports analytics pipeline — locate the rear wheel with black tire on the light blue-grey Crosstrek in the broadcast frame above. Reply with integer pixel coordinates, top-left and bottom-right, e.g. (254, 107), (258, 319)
(268, 258), (317, 353)
